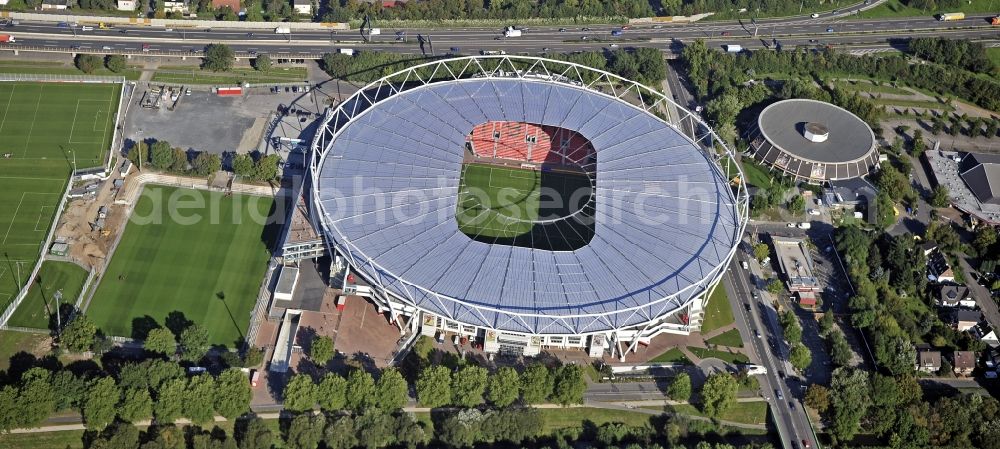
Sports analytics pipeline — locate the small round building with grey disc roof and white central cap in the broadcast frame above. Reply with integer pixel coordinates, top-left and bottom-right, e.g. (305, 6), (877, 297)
(747, 99), (878, 184)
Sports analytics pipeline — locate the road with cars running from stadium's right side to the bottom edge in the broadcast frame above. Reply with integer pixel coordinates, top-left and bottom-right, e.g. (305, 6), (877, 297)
(723, 251), (815, 448)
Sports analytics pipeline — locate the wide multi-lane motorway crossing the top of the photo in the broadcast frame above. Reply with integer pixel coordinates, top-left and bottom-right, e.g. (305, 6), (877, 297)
(0, 16), (1000, 57)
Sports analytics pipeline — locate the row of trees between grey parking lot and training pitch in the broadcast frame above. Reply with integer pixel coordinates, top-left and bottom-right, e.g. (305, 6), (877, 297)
(127, 139), (281, 181)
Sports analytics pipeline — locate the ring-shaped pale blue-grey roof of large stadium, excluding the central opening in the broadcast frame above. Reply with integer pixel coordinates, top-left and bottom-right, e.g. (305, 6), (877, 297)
(311, 56), (747, 356)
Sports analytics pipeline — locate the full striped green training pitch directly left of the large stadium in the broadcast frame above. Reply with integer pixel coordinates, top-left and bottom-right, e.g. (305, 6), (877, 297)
(86, 186), (274, 345)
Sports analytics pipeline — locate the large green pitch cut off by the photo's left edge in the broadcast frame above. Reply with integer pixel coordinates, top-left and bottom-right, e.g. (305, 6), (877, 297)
(0, 82), (121, 316)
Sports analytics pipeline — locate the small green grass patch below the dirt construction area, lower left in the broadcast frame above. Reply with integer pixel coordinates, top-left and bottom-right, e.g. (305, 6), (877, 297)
(8, 260), (87, 329)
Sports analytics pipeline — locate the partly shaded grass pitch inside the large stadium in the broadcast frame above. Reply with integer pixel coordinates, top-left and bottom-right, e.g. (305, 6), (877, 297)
(455, 164), (594, 250)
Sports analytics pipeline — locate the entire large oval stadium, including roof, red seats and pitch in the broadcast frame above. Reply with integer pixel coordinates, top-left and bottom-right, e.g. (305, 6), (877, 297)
(310, 56), (747, 357)
